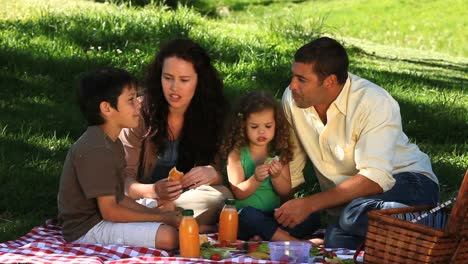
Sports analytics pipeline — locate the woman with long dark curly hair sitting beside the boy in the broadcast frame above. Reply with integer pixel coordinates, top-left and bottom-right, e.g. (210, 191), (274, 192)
(120, 39), (232, 225)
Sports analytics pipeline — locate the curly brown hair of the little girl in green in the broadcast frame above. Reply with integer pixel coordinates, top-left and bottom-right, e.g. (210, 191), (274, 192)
(219, 91), (293, 163)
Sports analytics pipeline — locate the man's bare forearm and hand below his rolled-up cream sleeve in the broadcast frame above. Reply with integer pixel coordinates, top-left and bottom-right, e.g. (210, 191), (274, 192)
(275, 174), (383, 227)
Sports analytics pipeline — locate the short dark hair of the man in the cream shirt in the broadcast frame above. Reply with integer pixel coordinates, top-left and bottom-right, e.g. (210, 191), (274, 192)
(294, 37), (349, 84)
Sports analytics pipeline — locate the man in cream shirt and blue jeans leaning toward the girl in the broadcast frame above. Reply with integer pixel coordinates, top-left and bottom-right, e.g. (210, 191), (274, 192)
(275, 37), (439, 249)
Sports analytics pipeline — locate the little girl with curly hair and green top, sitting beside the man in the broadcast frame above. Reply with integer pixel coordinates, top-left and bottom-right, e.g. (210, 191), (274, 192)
(221, 91), (320, 241)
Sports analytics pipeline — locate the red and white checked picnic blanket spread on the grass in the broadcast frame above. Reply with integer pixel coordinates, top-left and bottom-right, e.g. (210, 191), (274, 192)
(0, 220), (362, 264)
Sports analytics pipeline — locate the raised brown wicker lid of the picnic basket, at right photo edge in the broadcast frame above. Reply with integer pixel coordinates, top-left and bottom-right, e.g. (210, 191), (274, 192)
(447, 170), (468, 236)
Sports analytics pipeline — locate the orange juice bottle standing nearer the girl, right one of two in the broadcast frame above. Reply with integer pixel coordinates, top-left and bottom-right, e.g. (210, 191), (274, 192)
(218, 199), (239, 242)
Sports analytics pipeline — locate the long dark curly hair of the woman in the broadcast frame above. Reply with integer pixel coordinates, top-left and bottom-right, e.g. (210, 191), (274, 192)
(141, 39), (229, 172)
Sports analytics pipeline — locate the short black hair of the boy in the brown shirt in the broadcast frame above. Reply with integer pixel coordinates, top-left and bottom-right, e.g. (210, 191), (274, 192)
(77, 68), (137, 126)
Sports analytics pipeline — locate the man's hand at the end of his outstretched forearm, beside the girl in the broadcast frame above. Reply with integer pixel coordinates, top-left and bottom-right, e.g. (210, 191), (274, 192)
(275, 198), (312, 228)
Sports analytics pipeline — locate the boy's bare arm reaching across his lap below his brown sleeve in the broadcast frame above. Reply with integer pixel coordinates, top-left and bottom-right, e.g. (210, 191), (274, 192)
(97, 195), (180, 227)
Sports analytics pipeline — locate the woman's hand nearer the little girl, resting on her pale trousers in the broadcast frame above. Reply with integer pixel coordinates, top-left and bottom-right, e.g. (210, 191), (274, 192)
(180, 166), (218, 189)
